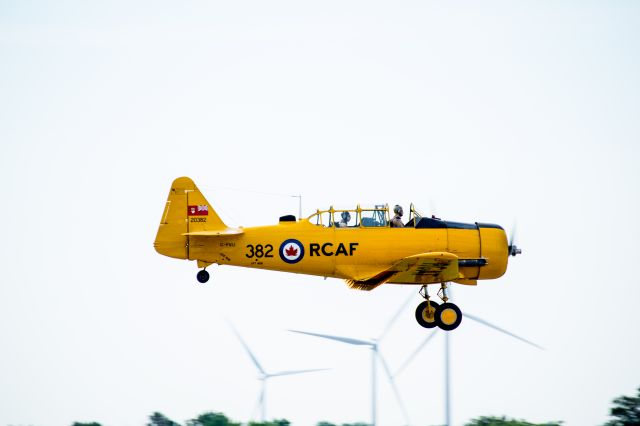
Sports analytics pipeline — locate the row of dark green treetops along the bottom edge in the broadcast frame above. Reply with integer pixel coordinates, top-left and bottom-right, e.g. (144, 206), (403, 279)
(72, 388), (640, 426)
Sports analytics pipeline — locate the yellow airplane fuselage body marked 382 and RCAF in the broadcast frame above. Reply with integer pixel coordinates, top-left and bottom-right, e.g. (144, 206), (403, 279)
(188, 218), (508, 284)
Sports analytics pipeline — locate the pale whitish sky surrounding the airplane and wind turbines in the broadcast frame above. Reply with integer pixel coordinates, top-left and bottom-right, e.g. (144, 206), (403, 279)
(0, 1), (640, 426)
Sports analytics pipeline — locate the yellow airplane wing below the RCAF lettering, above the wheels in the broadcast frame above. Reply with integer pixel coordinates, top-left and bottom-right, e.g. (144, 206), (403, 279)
(347, 252), (460, 290)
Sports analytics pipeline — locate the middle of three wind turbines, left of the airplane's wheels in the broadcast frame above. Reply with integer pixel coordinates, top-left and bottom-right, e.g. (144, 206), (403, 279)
(289, 293), (414, 426)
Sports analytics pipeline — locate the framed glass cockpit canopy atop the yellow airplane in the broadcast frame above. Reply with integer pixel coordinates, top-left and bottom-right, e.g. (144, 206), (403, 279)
(307, 204), (422, 228)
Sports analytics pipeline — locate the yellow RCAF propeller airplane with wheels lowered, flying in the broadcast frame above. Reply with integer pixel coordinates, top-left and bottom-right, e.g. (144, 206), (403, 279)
(154, 177), (521, 330)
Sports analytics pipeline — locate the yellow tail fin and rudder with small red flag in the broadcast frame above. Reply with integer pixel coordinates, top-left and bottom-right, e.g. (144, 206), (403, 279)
(153, 177), (230, 259)
